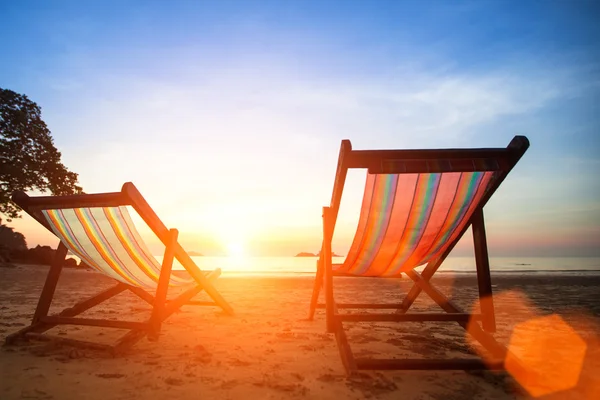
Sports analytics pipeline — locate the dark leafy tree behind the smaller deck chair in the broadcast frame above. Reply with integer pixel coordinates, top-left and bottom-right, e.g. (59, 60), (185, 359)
(0, 88), (81, 221)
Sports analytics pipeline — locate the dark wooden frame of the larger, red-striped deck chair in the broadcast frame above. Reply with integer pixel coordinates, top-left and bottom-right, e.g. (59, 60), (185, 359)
(308, 136), (529, 375)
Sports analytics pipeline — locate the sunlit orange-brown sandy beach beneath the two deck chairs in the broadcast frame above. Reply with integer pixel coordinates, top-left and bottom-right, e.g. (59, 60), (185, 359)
(0, 265), (600, 400)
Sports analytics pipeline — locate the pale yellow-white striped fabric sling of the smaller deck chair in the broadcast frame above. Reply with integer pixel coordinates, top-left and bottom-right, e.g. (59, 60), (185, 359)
(42, 207), (193, 289)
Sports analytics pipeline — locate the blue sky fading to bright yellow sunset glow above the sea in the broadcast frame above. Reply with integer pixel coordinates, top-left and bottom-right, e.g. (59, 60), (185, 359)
(0, 0), (600, 257)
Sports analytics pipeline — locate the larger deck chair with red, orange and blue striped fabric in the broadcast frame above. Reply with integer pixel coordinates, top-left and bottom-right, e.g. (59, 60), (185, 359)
(309, 136), (529, 374)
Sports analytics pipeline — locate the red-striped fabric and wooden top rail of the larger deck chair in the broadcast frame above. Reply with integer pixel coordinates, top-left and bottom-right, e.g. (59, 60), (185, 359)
(330, 136), (529, 276)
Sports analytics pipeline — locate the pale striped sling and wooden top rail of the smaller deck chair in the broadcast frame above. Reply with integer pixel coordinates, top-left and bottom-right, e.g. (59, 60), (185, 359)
(13, 183), (193, 289)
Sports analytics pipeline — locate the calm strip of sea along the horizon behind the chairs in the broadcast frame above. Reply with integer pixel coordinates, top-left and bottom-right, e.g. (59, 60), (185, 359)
(163, 256), (600, 276)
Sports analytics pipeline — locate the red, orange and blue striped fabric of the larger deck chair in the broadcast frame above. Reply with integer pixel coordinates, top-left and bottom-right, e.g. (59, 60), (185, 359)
(334, 172), (494, 276)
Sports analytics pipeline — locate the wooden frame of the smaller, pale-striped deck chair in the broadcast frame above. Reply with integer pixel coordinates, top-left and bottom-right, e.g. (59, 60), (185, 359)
(5, 182), (234, 354)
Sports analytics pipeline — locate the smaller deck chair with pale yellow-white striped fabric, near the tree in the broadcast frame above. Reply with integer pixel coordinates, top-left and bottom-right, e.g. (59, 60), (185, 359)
(6, 182), (233, 354)
